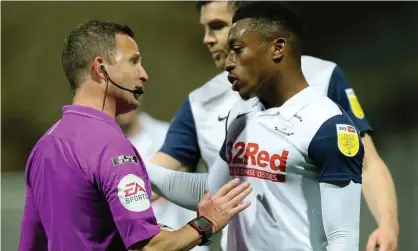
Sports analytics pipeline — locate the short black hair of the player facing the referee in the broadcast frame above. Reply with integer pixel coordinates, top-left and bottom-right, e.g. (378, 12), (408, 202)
(232, 1), (304, 58)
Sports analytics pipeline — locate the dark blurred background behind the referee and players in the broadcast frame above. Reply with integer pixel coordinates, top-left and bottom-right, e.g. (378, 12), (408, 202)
(1, 2), (418, 251)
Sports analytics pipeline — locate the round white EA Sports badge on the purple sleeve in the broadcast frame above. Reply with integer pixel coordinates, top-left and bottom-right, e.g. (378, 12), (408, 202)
(118, 174), (151, 212)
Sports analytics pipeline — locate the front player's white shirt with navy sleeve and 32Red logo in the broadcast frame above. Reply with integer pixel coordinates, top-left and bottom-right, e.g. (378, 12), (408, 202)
(220, 86), (364, 251)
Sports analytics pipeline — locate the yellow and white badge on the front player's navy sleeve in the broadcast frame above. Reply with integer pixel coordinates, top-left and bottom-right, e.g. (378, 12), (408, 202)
(337, 124), (360, 157)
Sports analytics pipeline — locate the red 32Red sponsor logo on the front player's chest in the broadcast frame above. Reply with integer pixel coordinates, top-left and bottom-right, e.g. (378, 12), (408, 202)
(227, 141), (289, 182)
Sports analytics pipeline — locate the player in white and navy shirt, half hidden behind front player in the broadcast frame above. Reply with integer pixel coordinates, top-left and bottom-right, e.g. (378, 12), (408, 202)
(153, 1), (398, 251)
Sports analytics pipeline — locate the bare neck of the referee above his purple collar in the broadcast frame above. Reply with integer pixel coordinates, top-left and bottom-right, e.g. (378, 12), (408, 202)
(73, 86), (116, 119)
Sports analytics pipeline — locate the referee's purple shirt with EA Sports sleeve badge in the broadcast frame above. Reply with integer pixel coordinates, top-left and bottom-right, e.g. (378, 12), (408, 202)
(19, 105), (160, 251)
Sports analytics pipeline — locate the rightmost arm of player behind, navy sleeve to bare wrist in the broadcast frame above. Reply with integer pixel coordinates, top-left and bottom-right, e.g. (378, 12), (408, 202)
(328, 66), (399, 233)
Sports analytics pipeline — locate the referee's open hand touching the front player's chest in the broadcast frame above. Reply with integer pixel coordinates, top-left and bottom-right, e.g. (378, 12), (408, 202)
(197, 179), (252, 233)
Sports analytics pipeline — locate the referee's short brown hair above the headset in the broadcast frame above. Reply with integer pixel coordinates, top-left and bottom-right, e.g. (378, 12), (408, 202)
(61, 20), (134, 92)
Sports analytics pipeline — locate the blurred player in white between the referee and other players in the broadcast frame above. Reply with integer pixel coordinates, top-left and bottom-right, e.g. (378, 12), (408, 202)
(117, 111), (209, 251)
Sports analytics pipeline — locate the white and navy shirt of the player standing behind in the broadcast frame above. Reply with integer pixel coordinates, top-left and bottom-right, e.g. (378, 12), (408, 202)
(160, 55), (372, 250)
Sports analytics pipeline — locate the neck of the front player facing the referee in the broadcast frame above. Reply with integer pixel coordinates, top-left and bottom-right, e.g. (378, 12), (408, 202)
(260, 69), (308, 109)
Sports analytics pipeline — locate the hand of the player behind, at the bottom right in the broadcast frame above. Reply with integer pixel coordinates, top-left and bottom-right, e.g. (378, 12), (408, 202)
(367, 228), (398, 251)
